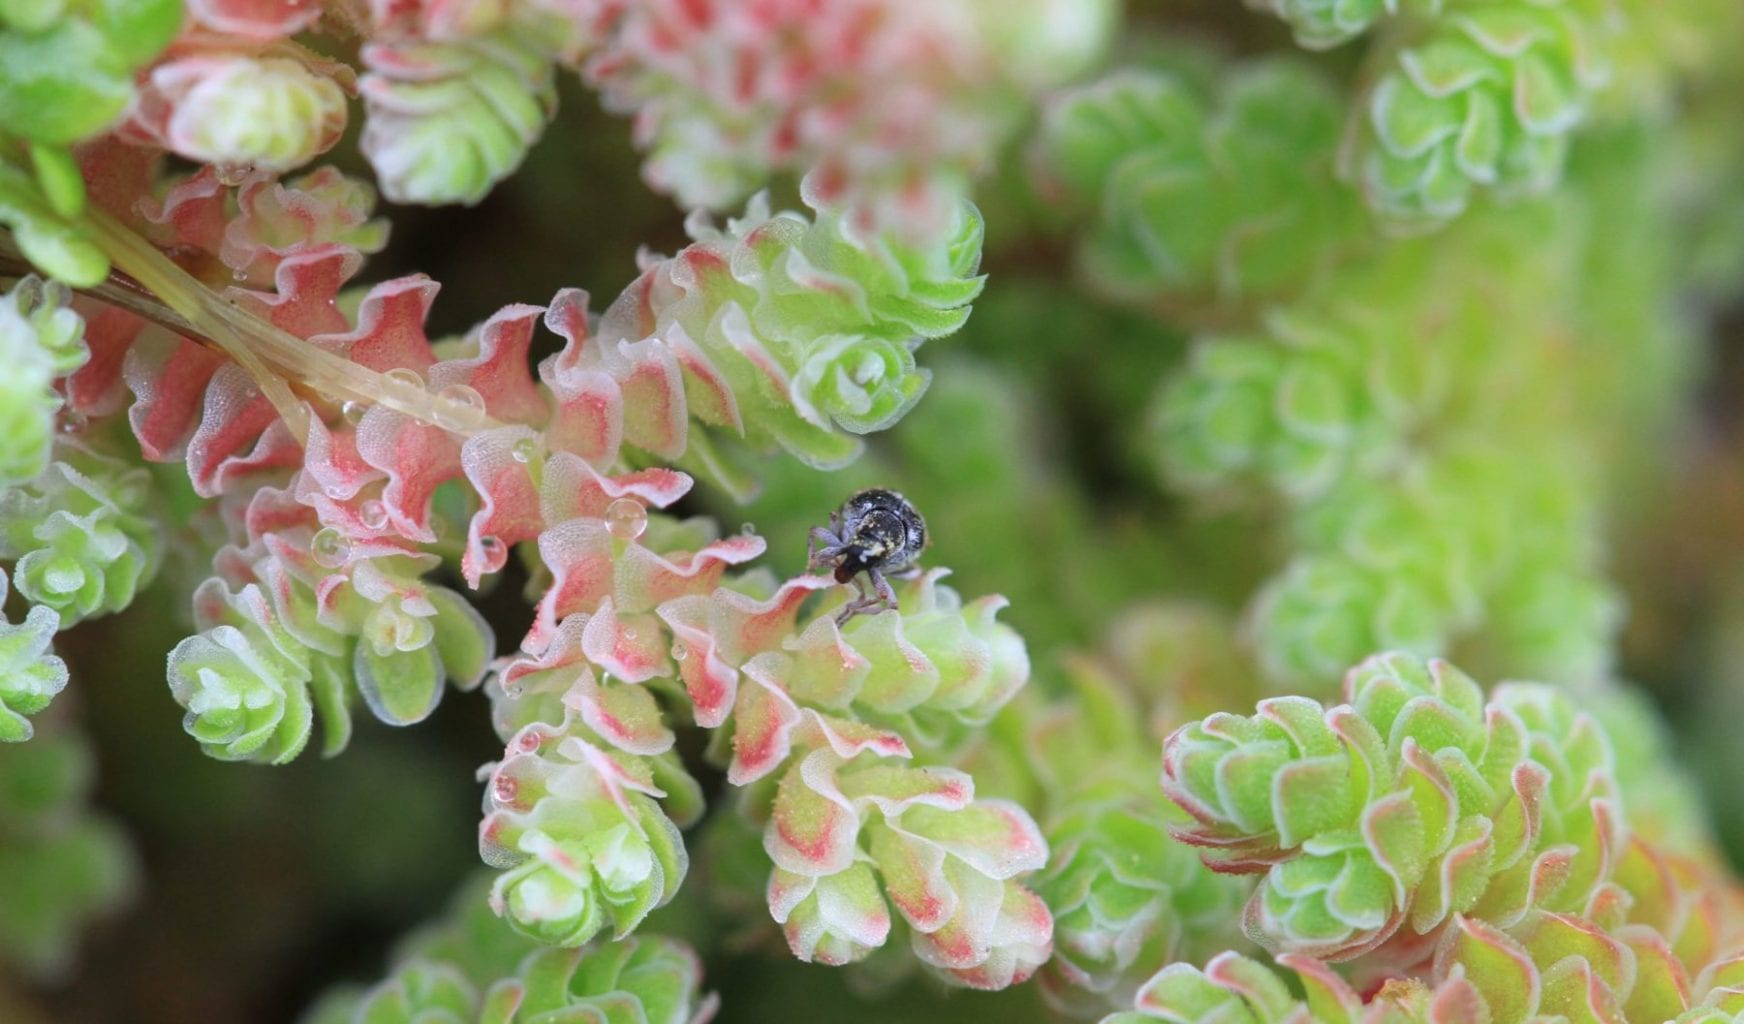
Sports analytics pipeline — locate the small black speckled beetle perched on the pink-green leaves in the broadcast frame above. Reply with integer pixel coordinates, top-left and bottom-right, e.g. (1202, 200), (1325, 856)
(806, 487), (926, 625)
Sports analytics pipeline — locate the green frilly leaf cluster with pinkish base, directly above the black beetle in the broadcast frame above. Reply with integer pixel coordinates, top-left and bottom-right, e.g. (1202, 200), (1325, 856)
(596, 197), (982, 466)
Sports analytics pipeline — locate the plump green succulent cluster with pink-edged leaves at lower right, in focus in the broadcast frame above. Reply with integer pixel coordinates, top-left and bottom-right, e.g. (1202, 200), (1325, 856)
(1163, 656), (1622, 959)
